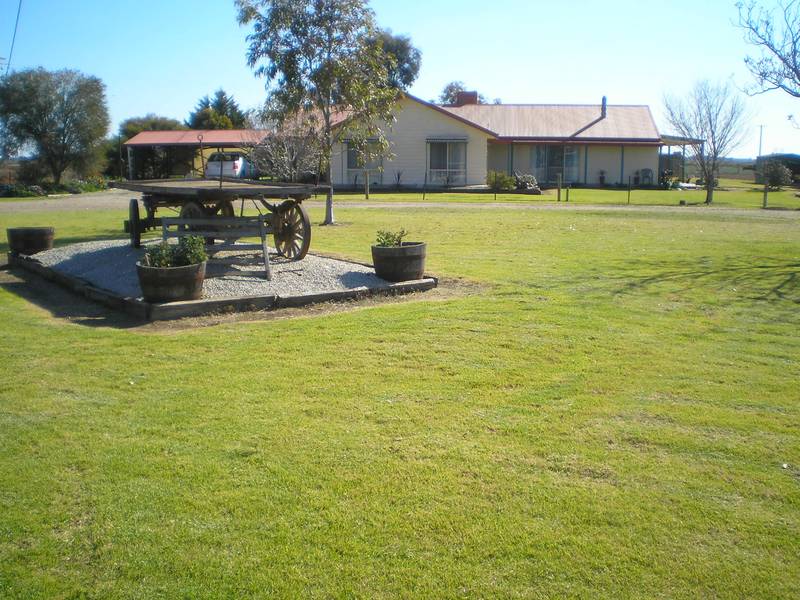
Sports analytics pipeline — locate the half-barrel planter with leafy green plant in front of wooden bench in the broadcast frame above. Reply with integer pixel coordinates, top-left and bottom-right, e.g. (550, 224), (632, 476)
(136, 236), (208, 302)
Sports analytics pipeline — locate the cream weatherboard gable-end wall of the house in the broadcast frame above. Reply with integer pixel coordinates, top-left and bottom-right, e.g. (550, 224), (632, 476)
(332, 98), (489, 186)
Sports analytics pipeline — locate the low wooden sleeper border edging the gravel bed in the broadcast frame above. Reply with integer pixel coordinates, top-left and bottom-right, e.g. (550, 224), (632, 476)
(8, 253), (438, 321)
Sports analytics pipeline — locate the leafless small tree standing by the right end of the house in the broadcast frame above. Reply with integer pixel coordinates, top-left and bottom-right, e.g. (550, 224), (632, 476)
(664, 81), (747, 204)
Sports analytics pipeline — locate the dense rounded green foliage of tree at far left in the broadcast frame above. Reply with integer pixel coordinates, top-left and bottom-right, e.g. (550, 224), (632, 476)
(0, 68), (109, 184)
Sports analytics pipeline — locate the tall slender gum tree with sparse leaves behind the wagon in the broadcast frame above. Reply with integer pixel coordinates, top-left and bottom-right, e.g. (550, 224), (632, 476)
(236, 0), (397, 223)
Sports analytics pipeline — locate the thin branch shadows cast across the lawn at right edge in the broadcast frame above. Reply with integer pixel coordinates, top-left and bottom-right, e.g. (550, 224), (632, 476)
(605, 258), (800, 304)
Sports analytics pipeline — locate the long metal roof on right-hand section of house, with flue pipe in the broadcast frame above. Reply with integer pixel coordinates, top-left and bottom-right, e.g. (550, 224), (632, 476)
(440, 104), (661, 144)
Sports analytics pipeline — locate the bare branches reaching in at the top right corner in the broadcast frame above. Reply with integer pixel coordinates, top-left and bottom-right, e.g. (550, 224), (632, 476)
(736, 0), (800, 98)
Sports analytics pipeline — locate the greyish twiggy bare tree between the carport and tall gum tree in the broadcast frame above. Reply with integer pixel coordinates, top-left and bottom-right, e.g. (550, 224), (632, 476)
(248, 112), (324, 183)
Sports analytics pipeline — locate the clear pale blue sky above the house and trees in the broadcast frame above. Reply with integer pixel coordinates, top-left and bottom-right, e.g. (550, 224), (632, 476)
(0, 0), (800, 156)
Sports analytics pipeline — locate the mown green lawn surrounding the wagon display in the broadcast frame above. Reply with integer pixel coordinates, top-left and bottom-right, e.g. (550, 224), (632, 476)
(0, 206), (800, 598)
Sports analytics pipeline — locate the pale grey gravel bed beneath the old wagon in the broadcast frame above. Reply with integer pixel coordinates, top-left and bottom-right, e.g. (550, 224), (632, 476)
(35, 240), (388, 299)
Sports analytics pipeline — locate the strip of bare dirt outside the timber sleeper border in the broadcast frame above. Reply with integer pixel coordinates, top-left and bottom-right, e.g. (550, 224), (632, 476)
(0, 270), (486, 333)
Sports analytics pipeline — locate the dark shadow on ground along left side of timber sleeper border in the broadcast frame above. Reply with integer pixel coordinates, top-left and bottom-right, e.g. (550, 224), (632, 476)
(0, 269), (143, 329)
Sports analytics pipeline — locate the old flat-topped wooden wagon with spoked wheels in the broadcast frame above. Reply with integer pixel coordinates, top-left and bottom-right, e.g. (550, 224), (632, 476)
(112, 179), (324, 260)
